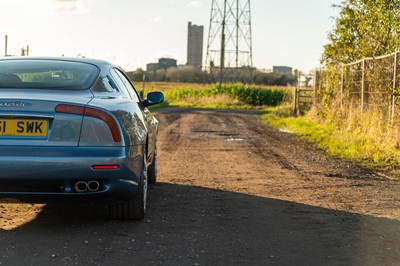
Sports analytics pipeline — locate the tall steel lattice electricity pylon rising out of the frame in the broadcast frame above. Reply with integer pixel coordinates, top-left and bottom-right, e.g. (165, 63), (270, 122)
(205, 0), (253, 82)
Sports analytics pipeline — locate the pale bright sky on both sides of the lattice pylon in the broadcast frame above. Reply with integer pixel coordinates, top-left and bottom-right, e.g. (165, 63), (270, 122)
(0, 0), (341, 71)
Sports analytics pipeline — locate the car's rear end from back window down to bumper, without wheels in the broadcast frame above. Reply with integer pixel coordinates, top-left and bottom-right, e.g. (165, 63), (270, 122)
(0, 59), (143, 202)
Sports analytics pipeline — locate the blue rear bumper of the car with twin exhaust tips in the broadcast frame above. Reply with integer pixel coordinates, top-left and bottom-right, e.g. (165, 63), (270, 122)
(0, 146), (143, 203)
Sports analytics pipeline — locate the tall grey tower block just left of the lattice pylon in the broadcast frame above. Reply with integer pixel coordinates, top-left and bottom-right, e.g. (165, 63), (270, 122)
(187, 22), (204, 68)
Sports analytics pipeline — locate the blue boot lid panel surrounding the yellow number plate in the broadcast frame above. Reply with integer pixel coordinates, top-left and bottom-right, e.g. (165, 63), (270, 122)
(0, 89), (93, 146)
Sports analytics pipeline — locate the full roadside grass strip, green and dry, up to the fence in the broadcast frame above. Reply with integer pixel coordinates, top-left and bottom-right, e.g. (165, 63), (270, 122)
(262, 107), (400, 169)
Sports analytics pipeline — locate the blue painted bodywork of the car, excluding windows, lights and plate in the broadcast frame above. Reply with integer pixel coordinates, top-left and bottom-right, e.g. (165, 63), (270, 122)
(0, 58), (162, 205)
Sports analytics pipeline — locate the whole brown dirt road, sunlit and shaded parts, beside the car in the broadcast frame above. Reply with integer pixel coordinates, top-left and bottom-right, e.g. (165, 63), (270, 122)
(0, 109), (400, 265)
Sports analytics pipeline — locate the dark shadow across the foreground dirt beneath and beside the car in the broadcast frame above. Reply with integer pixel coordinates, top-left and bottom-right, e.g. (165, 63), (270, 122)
(0, 183), (400, 265)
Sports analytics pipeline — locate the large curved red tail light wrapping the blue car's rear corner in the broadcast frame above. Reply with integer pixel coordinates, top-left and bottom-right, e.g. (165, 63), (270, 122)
(55, 104), (121, 142)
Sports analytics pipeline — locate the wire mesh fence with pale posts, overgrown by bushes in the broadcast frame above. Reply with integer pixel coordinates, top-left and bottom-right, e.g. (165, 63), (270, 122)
(316, 52), (400, 122)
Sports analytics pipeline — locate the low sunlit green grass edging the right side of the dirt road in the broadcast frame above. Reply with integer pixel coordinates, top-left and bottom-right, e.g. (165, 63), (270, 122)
(260, 106), (400, 168)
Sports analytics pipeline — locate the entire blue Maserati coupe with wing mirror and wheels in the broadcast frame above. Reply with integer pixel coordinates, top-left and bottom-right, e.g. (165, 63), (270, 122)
(0, 57), (164, 220)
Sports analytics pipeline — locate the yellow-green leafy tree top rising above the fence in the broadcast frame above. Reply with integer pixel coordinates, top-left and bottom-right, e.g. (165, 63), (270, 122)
(322, 0), (400, 65)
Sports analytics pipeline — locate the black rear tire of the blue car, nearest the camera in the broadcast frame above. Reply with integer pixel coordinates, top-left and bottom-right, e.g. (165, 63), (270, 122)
(110, 156), (148, 221)
